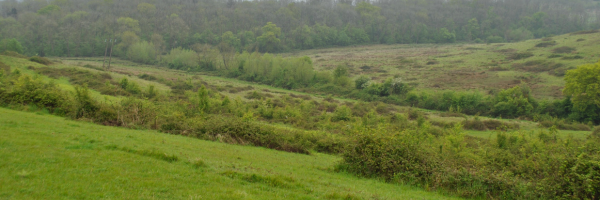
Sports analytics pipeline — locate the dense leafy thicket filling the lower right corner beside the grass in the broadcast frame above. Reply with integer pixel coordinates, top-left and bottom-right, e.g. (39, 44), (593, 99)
(337, 124), (600, 199)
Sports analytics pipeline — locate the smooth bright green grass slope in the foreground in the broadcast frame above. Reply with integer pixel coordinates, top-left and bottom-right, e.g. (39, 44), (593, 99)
(0, 108), (462, 199)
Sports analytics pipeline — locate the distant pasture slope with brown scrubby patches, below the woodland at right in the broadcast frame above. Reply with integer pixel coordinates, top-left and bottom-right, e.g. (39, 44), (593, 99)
(284, 31), (600, 99)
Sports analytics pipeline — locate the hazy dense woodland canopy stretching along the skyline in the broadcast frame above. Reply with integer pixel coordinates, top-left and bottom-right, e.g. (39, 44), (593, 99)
(0, 0), (600, 56)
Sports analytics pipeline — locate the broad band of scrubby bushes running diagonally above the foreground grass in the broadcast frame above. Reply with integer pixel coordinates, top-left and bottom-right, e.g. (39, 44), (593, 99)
(0, 57), (600, 199)
